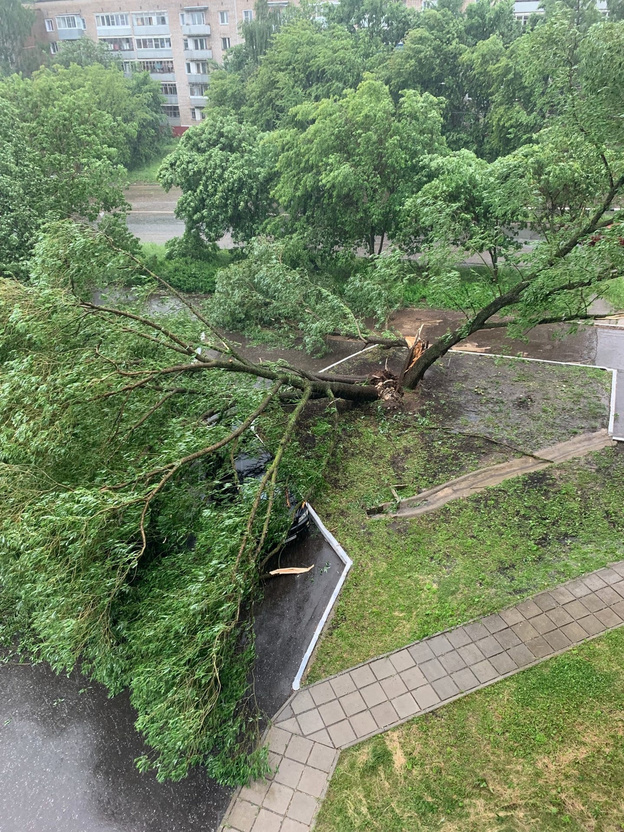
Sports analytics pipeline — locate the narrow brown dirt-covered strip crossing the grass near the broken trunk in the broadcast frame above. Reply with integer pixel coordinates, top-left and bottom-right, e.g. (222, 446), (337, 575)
(371, 430), (613, 517)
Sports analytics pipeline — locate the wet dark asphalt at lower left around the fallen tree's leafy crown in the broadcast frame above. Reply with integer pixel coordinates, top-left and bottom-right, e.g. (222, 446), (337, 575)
(0, 530), (343, 832)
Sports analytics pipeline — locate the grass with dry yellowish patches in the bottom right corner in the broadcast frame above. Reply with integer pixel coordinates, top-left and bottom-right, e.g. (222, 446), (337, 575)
(315, 630), (624, 832)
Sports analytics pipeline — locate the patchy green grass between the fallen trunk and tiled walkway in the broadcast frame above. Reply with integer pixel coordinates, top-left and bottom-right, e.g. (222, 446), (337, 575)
(309, 359), (624, 681)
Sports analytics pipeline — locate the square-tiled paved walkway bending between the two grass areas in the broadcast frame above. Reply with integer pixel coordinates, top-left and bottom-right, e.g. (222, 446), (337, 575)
(223, 561), (624, 832)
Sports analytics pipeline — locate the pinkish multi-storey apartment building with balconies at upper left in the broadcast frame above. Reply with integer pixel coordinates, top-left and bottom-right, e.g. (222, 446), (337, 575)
(26, 0), (288, 133)
